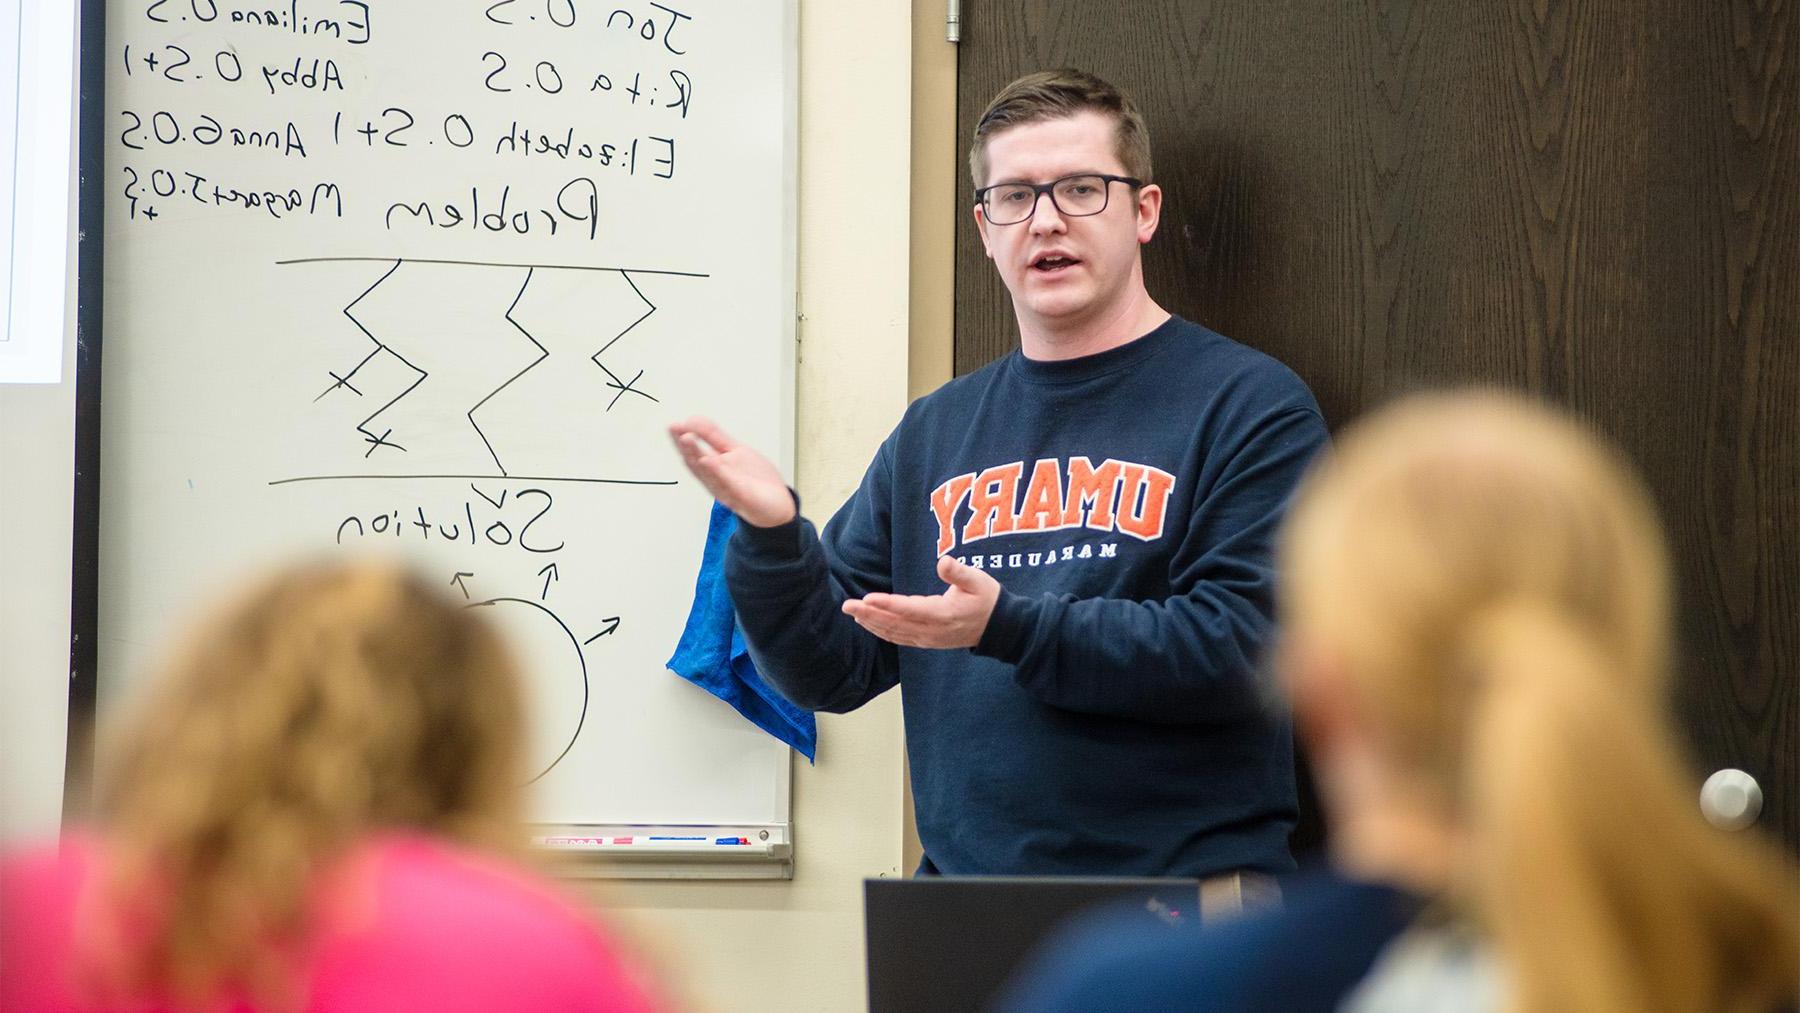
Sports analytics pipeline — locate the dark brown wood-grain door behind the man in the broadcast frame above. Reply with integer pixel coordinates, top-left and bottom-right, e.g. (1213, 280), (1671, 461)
(956, 0), (1800, 851)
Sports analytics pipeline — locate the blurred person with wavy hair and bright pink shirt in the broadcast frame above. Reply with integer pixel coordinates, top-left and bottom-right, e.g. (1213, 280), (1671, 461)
(0, 565), (657, 1013)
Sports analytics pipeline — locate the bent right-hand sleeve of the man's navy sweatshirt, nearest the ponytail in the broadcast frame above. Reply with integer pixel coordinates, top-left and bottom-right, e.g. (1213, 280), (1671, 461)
(974, 408), (1327, 723)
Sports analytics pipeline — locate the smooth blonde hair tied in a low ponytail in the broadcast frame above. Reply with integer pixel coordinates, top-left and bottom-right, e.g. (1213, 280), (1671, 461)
(1282, 392), (1800, 1013)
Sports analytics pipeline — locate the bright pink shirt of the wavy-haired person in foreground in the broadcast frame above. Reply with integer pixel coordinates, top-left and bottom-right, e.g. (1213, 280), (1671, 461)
(0, 835), (657, 1013)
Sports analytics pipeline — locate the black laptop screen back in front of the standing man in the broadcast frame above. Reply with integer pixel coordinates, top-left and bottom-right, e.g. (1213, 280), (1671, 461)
(862, 876), (1201, 1013)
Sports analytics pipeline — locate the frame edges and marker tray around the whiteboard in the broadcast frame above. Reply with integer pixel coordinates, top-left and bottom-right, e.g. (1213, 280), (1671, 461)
(63, 0), (799, 880)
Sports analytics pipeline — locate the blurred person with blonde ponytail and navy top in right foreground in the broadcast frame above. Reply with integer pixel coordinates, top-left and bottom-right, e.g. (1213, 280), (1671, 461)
(1010, 394), (1800, 1013)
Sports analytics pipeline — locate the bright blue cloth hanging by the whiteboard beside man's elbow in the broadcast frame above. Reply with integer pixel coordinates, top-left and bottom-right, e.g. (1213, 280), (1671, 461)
(668, 502), (819, 759)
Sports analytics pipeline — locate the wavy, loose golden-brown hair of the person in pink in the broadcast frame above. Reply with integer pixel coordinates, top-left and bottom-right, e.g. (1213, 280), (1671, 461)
(88, 563), (524, 1006)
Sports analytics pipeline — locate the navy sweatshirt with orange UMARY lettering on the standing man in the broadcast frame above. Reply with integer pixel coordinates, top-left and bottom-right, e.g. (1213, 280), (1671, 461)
(725, 318), (1327, 876)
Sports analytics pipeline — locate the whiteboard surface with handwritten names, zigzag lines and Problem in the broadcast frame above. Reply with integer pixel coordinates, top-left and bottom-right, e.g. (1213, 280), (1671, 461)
(99, 0), (796, 870)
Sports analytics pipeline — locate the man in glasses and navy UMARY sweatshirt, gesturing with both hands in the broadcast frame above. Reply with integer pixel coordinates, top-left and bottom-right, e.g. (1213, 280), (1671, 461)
(670, 70), (1325, 885)
